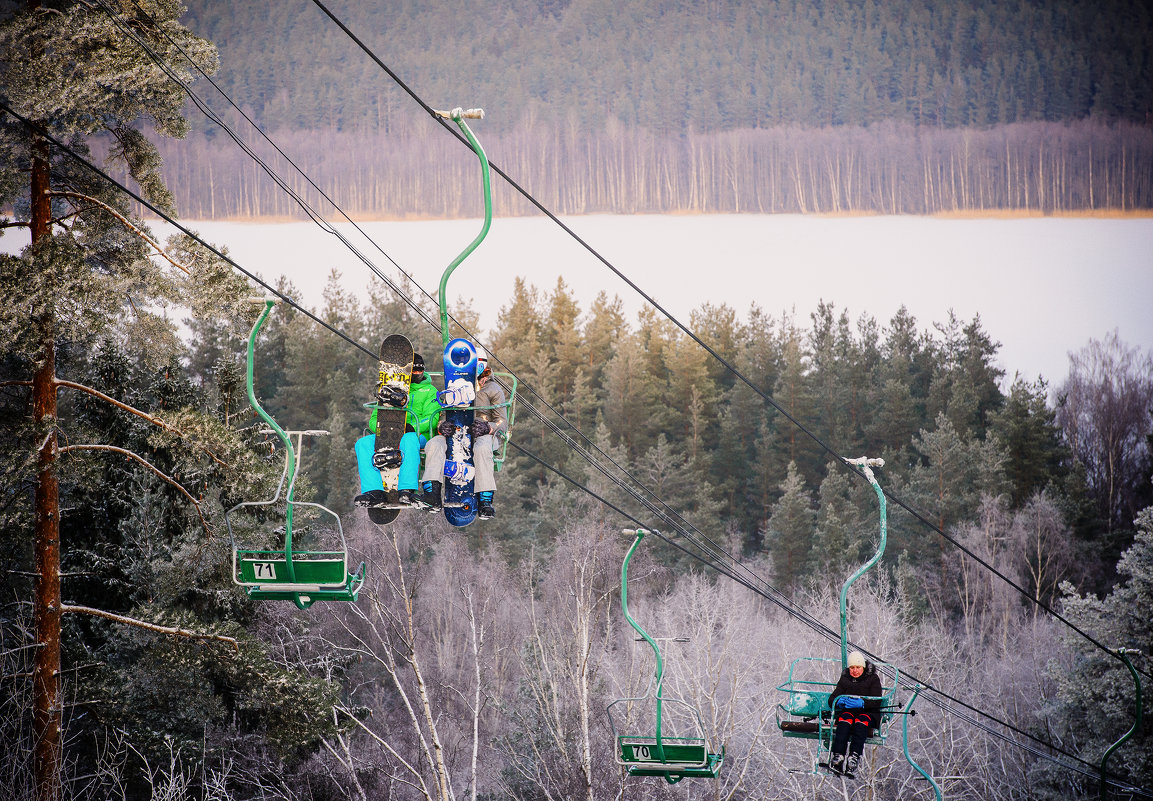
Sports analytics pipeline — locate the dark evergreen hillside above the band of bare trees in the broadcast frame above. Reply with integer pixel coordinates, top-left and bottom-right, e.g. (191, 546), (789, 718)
(188, 0), (1153, 134)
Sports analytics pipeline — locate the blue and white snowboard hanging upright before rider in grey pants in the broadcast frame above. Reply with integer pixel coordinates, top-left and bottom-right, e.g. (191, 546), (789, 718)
(442, 339), (476, 528)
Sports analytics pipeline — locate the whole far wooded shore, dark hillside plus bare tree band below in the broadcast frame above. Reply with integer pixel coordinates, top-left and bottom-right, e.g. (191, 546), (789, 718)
(165, 0), (1153, 217)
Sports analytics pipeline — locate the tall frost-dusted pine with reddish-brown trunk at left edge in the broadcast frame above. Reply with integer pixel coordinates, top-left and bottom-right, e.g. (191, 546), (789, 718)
(0, 0), (331, 801)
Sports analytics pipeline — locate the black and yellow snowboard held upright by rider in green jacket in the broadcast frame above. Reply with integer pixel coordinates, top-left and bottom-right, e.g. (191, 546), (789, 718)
(368, 334), (413, 526)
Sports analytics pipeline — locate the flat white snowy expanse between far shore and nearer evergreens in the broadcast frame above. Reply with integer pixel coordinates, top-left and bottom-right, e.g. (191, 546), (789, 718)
(0, 214), (1153, 384)
